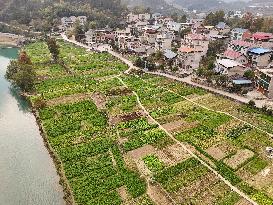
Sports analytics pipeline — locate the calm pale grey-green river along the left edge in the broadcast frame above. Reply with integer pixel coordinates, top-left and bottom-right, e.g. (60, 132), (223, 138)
(0, 48), (65, 205)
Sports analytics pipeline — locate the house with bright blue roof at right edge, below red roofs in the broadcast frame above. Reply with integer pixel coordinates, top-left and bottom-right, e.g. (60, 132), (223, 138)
(248, 48), (272, 67)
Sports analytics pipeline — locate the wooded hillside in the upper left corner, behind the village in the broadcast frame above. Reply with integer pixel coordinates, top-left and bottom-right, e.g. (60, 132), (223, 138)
(0, 0), (125, 30)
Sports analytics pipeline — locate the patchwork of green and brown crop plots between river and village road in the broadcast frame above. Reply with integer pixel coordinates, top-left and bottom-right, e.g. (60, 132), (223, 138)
(26, 42), (273, 205)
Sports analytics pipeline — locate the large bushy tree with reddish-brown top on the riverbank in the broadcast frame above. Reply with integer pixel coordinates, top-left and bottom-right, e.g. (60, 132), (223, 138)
(5, 51), (36, 92)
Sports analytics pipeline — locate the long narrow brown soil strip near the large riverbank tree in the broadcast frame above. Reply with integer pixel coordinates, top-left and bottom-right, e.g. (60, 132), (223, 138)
(46, 93), (91, 106)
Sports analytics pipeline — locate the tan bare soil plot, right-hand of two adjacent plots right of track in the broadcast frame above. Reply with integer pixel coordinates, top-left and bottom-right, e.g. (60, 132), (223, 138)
(224, 149), (254, 169)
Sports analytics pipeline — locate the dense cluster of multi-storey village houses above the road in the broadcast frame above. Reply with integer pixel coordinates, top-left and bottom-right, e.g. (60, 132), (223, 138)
(62, 13), (273, 96)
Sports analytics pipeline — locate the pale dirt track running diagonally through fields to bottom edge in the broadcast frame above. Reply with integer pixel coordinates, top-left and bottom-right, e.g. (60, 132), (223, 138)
(117, 77), (258, 205)
